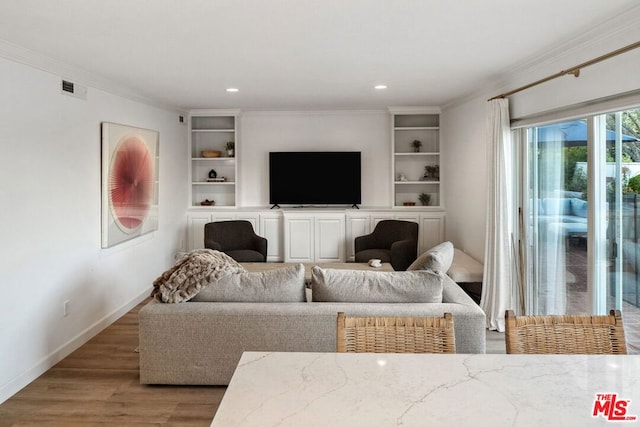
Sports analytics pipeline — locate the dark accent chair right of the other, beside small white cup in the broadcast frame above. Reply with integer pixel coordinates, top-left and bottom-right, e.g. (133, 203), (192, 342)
(354, 219), (418, 271)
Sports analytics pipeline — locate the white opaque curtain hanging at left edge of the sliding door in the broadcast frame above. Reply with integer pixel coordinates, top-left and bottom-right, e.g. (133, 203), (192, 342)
(480, 99), (515, 332)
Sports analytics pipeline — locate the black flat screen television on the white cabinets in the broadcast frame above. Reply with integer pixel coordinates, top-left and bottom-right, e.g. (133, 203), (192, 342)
(269, 151), (362, 207)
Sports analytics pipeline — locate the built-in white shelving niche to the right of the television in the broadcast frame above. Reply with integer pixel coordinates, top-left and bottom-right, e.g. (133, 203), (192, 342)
(390, 109), (442, 209)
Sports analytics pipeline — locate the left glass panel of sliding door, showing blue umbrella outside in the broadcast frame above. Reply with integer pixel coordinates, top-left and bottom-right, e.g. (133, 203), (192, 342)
(527, 120), (588, 314)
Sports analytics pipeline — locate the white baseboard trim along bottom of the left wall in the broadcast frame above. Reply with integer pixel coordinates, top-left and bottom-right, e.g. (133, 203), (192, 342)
(0, 289), (151, 404)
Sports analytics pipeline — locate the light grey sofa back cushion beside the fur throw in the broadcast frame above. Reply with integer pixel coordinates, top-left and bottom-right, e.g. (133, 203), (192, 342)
(191, 264), (306, 302)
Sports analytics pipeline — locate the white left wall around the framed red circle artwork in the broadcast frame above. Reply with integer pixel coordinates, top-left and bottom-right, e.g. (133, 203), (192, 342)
(0, 58), (188, 402)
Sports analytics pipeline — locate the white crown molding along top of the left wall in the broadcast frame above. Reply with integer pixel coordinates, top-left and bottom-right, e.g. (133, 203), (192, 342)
(0, 39), (185, 114)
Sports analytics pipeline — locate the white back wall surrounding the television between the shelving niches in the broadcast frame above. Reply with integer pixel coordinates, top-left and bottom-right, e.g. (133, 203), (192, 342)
(238, 111), (392, 207)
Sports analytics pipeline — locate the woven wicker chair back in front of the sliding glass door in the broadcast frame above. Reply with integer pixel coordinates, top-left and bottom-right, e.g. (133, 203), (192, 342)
(505, 310), (627, 354)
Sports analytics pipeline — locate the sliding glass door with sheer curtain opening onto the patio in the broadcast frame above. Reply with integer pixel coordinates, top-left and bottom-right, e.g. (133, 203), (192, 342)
(521, 110), (640, 314)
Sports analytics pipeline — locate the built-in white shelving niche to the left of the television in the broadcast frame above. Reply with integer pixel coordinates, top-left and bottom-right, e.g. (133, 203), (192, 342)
(189, 110), (238, 207)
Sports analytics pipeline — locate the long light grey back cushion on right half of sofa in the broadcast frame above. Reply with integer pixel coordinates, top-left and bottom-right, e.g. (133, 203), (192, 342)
(311, 266), (443, 303)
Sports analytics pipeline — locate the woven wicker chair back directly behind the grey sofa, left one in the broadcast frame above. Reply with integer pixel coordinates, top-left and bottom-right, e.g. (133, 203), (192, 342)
(336, 312), (456, 353)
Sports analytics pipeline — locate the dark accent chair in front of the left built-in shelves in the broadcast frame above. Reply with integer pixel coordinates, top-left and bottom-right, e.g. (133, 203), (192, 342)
(204, 220), (267, 262)
